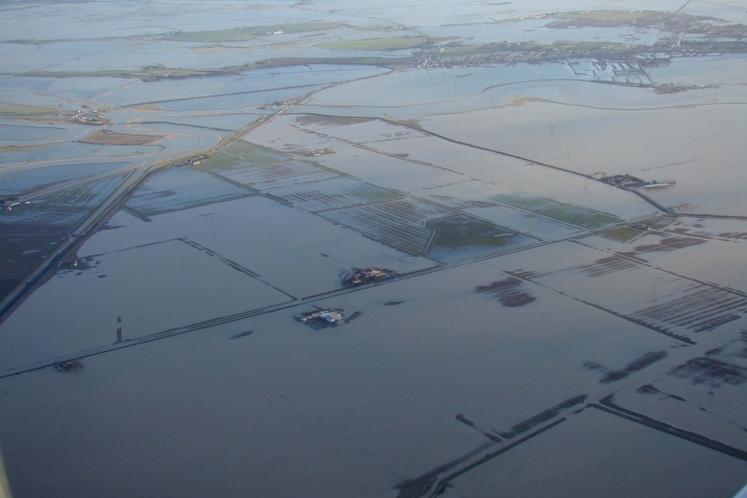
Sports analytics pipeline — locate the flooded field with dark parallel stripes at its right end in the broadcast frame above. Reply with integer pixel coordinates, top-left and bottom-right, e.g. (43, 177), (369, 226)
(491, 243), (747, 342)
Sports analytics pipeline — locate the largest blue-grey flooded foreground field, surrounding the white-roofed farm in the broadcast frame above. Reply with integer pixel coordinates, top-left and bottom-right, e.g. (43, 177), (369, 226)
(0, 260), (680, 498)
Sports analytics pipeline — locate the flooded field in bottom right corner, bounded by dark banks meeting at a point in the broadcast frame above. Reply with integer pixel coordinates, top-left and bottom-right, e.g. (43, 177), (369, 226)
(443, 409), (747, 498)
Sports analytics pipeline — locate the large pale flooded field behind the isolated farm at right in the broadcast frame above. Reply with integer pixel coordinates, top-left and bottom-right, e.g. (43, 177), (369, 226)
(420, 80), (747, 216)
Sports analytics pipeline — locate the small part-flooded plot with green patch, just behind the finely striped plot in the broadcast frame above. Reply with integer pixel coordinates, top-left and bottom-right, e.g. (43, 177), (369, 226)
(268, 176), (404, 212)
